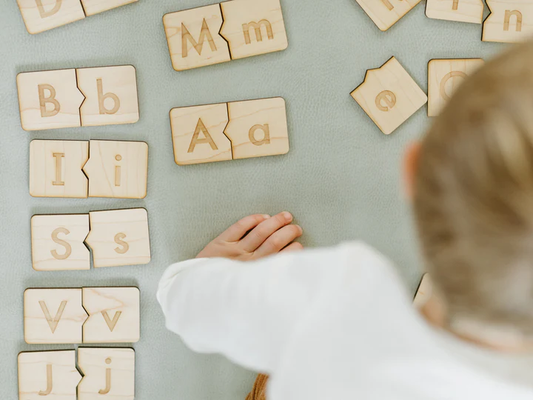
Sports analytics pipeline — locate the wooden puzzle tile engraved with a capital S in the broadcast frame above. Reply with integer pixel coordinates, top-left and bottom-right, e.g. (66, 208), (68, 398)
(31, 214), (91, 271)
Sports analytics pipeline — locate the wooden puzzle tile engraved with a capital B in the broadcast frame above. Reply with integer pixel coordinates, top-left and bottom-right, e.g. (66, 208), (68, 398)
(17, 69), (84, 131)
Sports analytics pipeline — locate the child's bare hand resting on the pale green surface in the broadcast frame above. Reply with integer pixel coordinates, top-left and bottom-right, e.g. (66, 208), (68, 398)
(197, 212), (303, 261)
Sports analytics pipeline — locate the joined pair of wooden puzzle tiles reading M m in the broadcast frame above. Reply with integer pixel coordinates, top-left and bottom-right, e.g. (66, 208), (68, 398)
(163, 0), (288, 71)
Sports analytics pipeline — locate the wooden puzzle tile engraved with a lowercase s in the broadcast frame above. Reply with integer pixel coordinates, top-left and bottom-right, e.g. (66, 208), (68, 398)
(85, 208), (150, 268)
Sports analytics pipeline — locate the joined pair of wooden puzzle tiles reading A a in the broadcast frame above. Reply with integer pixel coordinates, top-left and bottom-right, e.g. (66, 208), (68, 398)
(170, 97), (289, 165)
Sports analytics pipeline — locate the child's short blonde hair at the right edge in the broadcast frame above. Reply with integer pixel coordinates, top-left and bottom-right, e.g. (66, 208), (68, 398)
(414, 43), (533, 339)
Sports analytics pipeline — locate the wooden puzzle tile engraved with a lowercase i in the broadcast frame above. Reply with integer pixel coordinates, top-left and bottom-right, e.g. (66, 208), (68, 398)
(83, 140), (148, 199)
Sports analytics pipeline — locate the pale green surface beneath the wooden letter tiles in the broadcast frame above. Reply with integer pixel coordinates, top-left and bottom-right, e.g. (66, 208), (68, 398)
(0, 0), (500, 400)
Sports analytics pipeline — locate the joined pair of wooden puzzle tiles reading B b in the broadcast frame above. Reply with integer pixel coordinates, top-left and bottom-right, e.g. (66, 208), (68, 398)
(17, 65), (139, 131)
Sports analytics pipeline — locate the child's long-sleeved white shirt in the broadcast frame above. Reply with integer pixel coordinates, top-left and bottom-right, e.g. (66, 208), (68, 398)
(158, 243), (533, 400)
